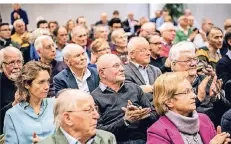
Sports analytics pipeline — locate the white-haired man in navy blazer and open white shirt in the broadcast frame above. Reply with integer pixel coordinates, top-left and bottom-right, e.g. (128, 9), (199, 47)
(54, 44), (99, 93)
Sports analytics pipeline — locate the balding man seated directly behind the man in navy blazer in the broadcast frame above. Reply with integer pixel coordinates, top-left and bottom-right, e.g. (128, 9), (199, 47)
(71, 25), (91, 63)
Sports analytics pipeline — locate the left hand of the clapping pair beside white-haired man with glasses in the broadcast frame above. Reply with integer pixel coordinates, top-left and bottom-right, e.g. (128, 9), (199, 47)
(197, 76), (211, 102)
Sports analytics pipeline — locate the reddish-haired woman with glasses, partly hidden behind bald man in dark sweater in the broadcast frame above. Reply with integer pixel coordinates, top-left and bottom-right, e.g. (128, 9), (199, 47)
(91, 38), (111, 64)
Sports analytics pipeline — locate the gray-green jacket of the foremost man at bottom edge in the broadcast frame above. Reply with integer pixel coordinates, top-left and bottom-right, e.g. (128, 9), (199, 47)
(38, 128), (116, 144)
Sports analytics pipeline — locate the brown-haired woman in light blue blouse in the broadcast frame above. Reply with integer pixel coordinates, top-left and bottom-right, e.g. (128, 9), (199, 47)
(3, 61), (55, 144)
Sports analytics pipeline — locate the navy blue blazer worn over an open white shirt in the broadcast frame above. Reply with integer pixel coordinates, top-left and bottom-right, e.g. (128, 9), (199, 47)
(53, 67), (99, 95)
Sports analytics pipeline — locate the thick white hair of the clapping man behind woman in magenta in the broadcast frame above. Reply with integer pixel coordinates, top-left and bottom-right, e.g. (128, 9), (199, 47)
(169, 41), (196, 61)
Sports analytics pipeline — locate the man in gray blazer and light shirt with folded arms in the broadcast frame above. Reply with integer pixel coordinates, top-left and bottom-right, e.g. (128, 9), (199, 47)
(125, 37), (161, 101)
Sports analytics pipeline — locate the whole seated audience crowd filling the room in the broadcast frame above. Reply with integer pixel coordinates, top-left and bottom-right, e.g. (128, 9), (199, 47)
(0, 4), (231, 144)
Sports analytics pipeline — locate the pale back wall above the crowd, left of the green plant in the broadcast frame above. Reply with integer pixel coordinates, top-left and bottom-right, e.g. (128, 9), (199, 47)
(0, 4), (149, 30)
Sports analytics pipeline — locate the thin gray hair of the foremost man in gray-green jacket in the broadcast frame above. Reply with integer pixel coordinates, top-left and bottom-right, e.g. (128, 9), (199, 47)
(53, 89), (92, 128)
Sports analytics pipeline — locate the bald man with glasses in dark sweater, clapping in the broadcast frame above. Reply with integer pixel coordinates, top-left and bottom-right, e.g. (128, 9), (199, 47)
(91, 54), (157, 144)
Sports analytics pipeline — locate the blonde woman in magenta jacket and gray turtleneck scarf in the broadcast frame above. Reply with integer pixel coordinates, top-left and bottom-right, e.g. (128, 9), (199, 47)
(147, 72), (230, 144)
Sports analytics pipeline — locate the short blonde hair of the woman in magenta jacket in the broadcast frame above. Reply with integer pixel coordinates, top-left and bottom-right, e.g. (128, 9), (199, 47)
(153, 72), (188, 115)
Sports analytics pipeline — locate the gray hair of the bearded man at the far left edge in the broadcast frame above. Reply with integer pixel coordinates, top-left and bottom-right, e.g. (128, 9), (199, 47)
(0, 46), (23, 71)
